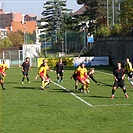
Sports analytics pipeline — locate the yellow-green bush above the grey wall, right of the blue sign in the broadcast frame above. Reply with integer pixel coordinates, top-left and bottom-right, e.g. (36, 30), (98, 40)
(97, 26), (111, 37)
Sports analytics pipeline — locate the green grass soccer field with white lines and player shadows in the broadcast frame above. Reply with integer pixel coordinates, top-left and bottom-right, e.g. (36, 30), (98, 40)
(0, 67), (133, 133)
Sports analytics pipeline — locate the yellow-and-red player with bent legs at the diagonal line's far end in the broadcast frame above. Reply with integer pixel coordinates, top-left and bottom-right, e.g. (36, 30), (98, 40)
(35, 59), (50, 90)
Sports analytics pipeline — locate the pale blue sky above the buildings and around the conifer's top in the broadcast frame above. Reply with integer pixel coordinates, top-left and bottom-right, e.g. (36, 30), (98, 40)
(0, 0), (82, 16)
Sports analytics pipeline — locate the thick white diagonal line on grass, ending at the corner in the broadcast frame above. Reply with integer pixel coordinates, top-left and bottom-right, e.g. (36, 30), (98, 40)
(51, 81), (93, 107)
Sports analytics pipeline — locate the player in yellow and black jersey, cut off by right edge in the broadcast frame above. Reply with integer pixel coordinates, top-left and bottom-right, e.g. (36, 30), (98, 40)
(124, 58), (133, 86)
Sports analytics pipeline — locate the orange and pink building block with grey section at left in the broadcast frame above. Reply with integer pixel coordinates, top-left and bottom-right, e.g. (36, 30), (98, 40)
(0, 9), (37, 34)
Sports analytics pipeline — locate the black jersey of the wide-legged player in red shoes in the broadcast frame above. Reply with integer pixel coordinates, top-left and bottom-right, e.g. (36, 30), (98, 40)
(113, 68), (125, 81)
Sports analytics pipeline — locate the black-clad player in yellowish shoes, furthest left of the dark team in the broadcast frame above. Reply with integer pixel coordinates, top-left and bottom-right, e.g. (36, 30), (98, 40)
(21, 57), (32, 84)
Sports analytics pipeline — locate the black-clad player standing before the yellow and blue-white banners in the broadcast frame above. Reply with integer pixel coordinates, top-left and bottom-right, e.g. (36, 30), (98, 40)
(55, 58), (64, 82)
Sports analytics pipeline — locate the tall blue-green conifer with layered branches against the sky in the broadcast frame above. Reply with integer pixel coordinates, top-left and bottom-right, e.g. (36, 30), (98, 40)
(40, 0), (71, 42)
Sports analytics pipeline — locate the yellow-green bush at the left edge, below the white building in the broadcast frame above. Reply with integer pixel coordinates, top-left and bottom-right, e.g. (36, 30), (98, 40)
(0, 38), (13, 48)
